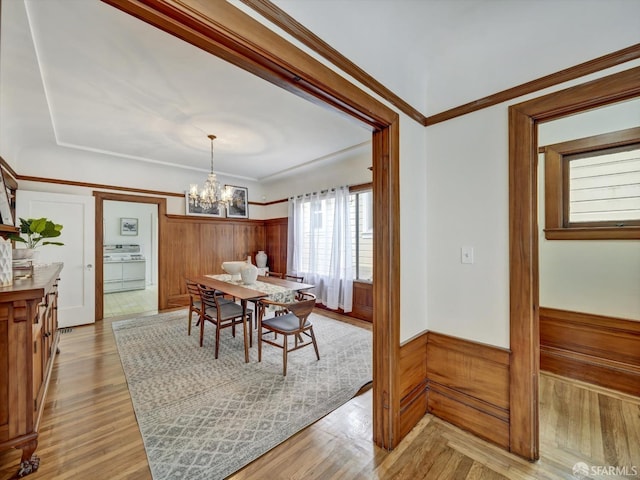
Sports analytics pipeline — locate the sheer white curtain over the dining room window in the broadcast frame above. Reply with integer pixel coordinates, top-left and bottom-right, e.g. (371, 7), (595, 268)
(287, 187), (353, 312)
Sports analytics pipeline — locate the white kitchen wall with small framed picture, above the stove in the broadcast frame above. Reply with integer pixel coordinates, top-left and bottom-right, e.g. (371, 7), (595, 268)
(102, 200), (158, 285)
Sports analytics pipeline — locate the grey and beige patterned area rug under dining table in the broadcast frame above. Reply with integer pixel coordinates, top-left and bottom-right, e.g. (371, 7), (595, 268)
(113, 310), (373, 480)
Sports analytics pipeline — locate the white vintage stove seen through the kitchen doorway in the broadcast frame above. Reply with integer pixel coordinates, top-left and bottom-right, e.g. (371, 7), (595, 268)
(103, 244), (147, 293)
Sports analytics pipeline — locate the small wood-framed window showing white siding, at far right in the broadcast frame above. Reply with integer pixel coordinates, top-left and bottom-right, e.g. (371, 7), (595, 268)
(543, 128), (640, 239)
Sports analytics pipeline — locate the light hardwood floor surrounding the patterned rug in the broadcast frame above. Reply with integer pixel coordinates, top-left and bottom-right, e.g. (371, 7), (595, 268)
(0, 312), (640, 480)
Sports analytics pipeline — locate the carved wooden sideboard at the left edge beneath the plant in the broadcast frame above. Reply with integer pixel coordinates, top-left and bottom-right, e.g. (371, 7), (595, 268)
(0, 263), (62, 477)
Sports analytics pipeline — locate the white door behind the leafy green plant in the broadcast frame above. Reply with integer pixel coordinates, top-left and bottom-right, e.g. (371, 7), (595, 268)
(16, 190), (95, 327)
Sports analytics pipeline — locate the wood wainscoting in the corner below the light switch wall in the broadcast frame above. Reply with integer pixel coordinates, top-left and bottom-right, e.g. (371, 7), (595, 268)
(400, 332), (510, 449)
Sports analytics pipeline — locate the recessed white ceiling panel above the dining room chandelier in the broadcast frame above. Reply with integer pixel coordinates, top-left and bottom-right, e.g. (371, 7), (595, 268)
(20, 0), (371, 180)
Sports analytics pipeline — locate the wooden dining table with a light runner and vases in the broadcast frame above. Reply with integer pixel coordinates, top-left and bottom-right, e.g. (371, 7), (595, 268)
(192, 274), (315, 363)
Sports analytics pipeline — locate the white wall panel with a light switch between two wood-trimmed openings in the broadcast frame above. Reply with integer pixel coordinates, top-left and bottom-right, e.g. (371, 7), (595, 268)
(426, 105), (509, 347)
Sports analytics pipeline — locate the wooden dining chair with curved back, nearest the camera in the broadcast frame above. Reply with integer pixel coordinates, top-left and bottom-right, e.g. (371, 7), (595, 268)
(258, 292), (320, 377)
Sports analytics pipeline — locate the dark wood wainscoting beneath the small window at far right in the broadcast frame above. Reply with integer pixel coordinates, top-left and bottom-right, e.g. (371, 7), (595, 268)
(540, 307), (640, 395)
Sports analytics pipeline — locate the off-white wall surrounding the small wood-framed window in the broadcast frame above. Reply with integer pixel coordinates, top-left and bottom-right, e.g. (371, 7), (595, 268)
(538, 100), (640, 321)
